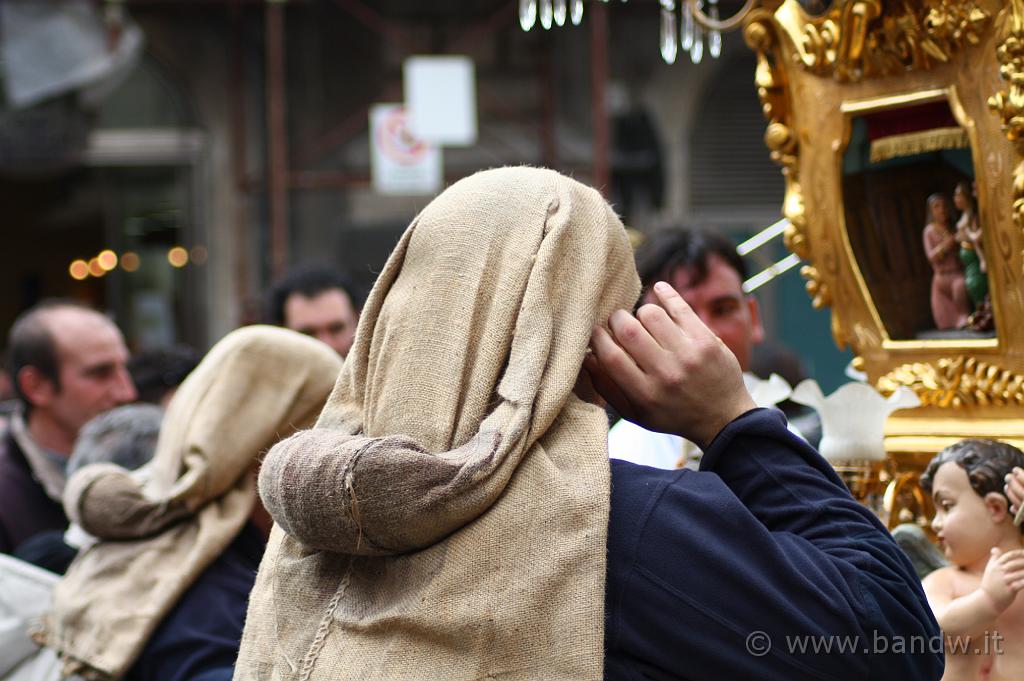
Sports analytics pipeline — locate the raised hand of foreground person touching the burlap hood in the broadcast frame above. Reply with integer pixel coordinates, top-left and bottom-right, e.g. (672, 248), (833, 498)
(584, 282), (756, 448)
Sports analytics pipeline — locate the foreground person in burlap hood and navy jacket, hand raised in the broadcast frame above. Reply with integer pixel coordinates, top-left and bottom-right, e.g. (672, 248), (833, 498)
(236, 168), (941, 681)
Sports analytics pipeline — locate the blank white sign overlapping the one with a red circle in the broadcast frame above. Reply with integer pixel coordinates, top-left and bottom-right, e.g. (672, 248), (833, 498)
(402, 55), (476, 146)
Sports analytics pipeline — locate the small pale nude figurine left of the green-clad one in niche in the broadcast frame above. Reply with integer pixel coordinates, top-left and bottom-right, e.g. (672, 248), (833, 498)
(924, 194), (971, 330)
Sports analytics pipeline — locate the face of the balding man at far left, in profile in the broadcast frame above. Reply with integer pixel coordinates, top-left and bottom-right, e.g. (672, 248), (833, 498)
(33, 307), (136, 438)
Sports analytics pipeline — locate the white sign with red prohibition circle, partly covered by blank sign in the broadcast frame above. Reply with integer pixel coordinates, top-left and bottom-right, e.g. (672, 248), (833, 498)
(370, 104), (444, 196)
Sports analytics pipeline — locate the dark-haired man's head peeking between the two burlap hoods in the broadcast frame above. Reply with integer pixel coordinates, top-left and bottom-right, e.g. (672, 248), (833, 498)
(267, 268), (359, 357)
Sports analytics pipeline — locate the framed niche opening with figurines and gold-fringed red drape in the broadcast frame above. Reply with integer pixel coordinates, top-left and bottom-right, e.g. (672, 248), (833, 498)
(842, 97), (995, 341)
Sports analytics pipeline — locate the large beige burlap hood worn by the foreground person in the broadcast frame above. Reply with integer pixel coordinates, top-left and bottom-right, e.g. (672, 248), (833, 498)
(236, 168), (639, 681)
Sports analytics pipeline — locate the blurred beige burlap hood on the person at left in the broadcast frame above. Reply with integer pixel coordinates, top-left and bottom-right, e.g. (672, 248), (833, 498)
(42, 327), (341, 679)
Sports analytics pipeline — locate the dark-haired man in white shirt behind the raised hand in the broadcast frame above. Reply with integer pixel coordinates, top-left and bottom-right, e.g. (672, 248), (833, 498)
(608, 229), (764, 468)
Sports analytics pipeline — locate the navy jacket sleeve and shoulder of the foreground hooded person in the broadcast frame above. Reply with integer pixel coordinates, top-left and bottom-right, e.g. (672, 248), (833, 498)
(605, 410), (943, 681)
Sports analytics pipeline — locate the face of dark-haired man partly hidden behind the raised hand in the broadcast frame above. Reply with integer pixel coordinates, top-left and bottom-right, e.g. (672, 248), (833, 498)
(643, 255), (764, 371)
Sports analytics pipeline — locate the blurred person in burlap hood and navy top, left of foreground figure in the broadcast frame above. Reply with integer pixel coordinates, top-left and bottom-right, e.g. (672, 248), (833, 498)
(38, 327), (341, 681)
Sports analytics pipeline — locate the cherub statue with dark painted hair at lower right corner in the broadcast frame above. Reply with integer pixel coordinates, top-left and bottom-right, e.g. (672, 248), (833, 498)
(921, 439), (1024, 681)
